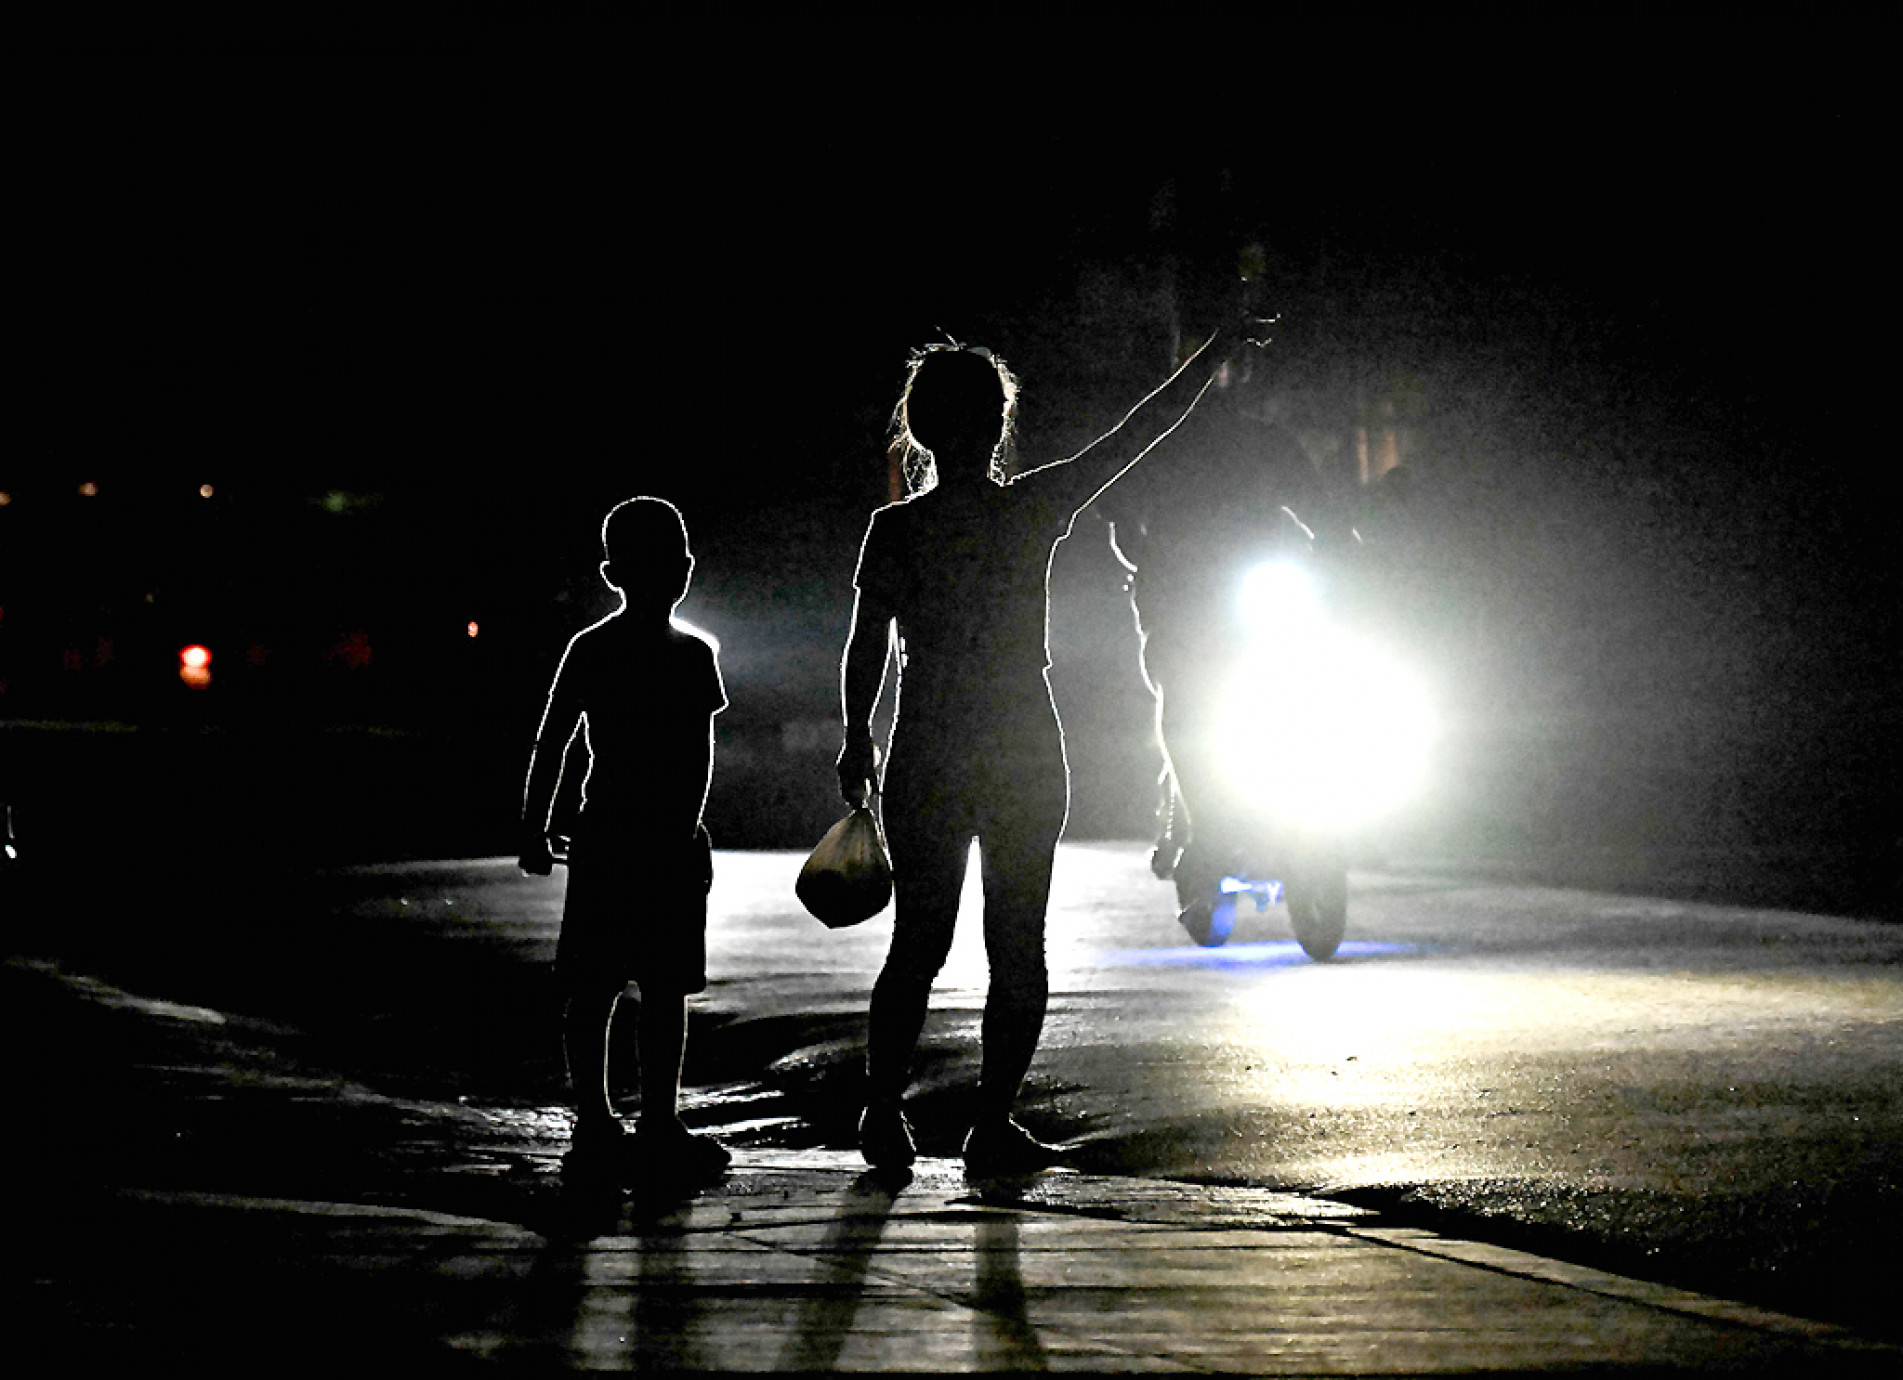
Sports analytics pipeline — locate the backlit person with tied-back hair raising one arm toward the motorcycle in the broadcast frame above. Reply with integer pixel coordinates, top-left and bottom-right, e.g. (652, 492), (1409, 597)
(839, 317), (1239, 1173)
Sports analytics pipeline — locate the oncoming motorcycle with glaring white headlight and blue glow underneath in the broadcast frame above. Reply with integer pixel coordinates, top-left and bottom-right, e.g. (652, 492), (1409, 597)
(1151, 508), (1431, 961)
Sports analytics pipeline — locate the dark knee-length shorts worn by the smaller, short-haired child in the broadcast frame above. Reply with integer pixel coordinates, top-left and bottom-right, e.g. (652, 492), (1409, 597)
(556, 818), (714, 992)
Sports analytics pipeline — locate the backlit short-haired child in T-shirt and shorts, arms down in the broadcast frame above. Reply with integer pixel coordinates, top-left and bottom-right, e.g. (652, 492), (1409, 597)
(521, 497), (729, 1180)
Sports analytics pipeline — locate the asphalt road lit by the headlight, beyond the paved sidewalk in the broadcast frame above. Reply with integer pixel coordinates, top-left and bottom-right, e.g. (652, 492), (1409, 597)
(15, 845), (1903, 1332)
